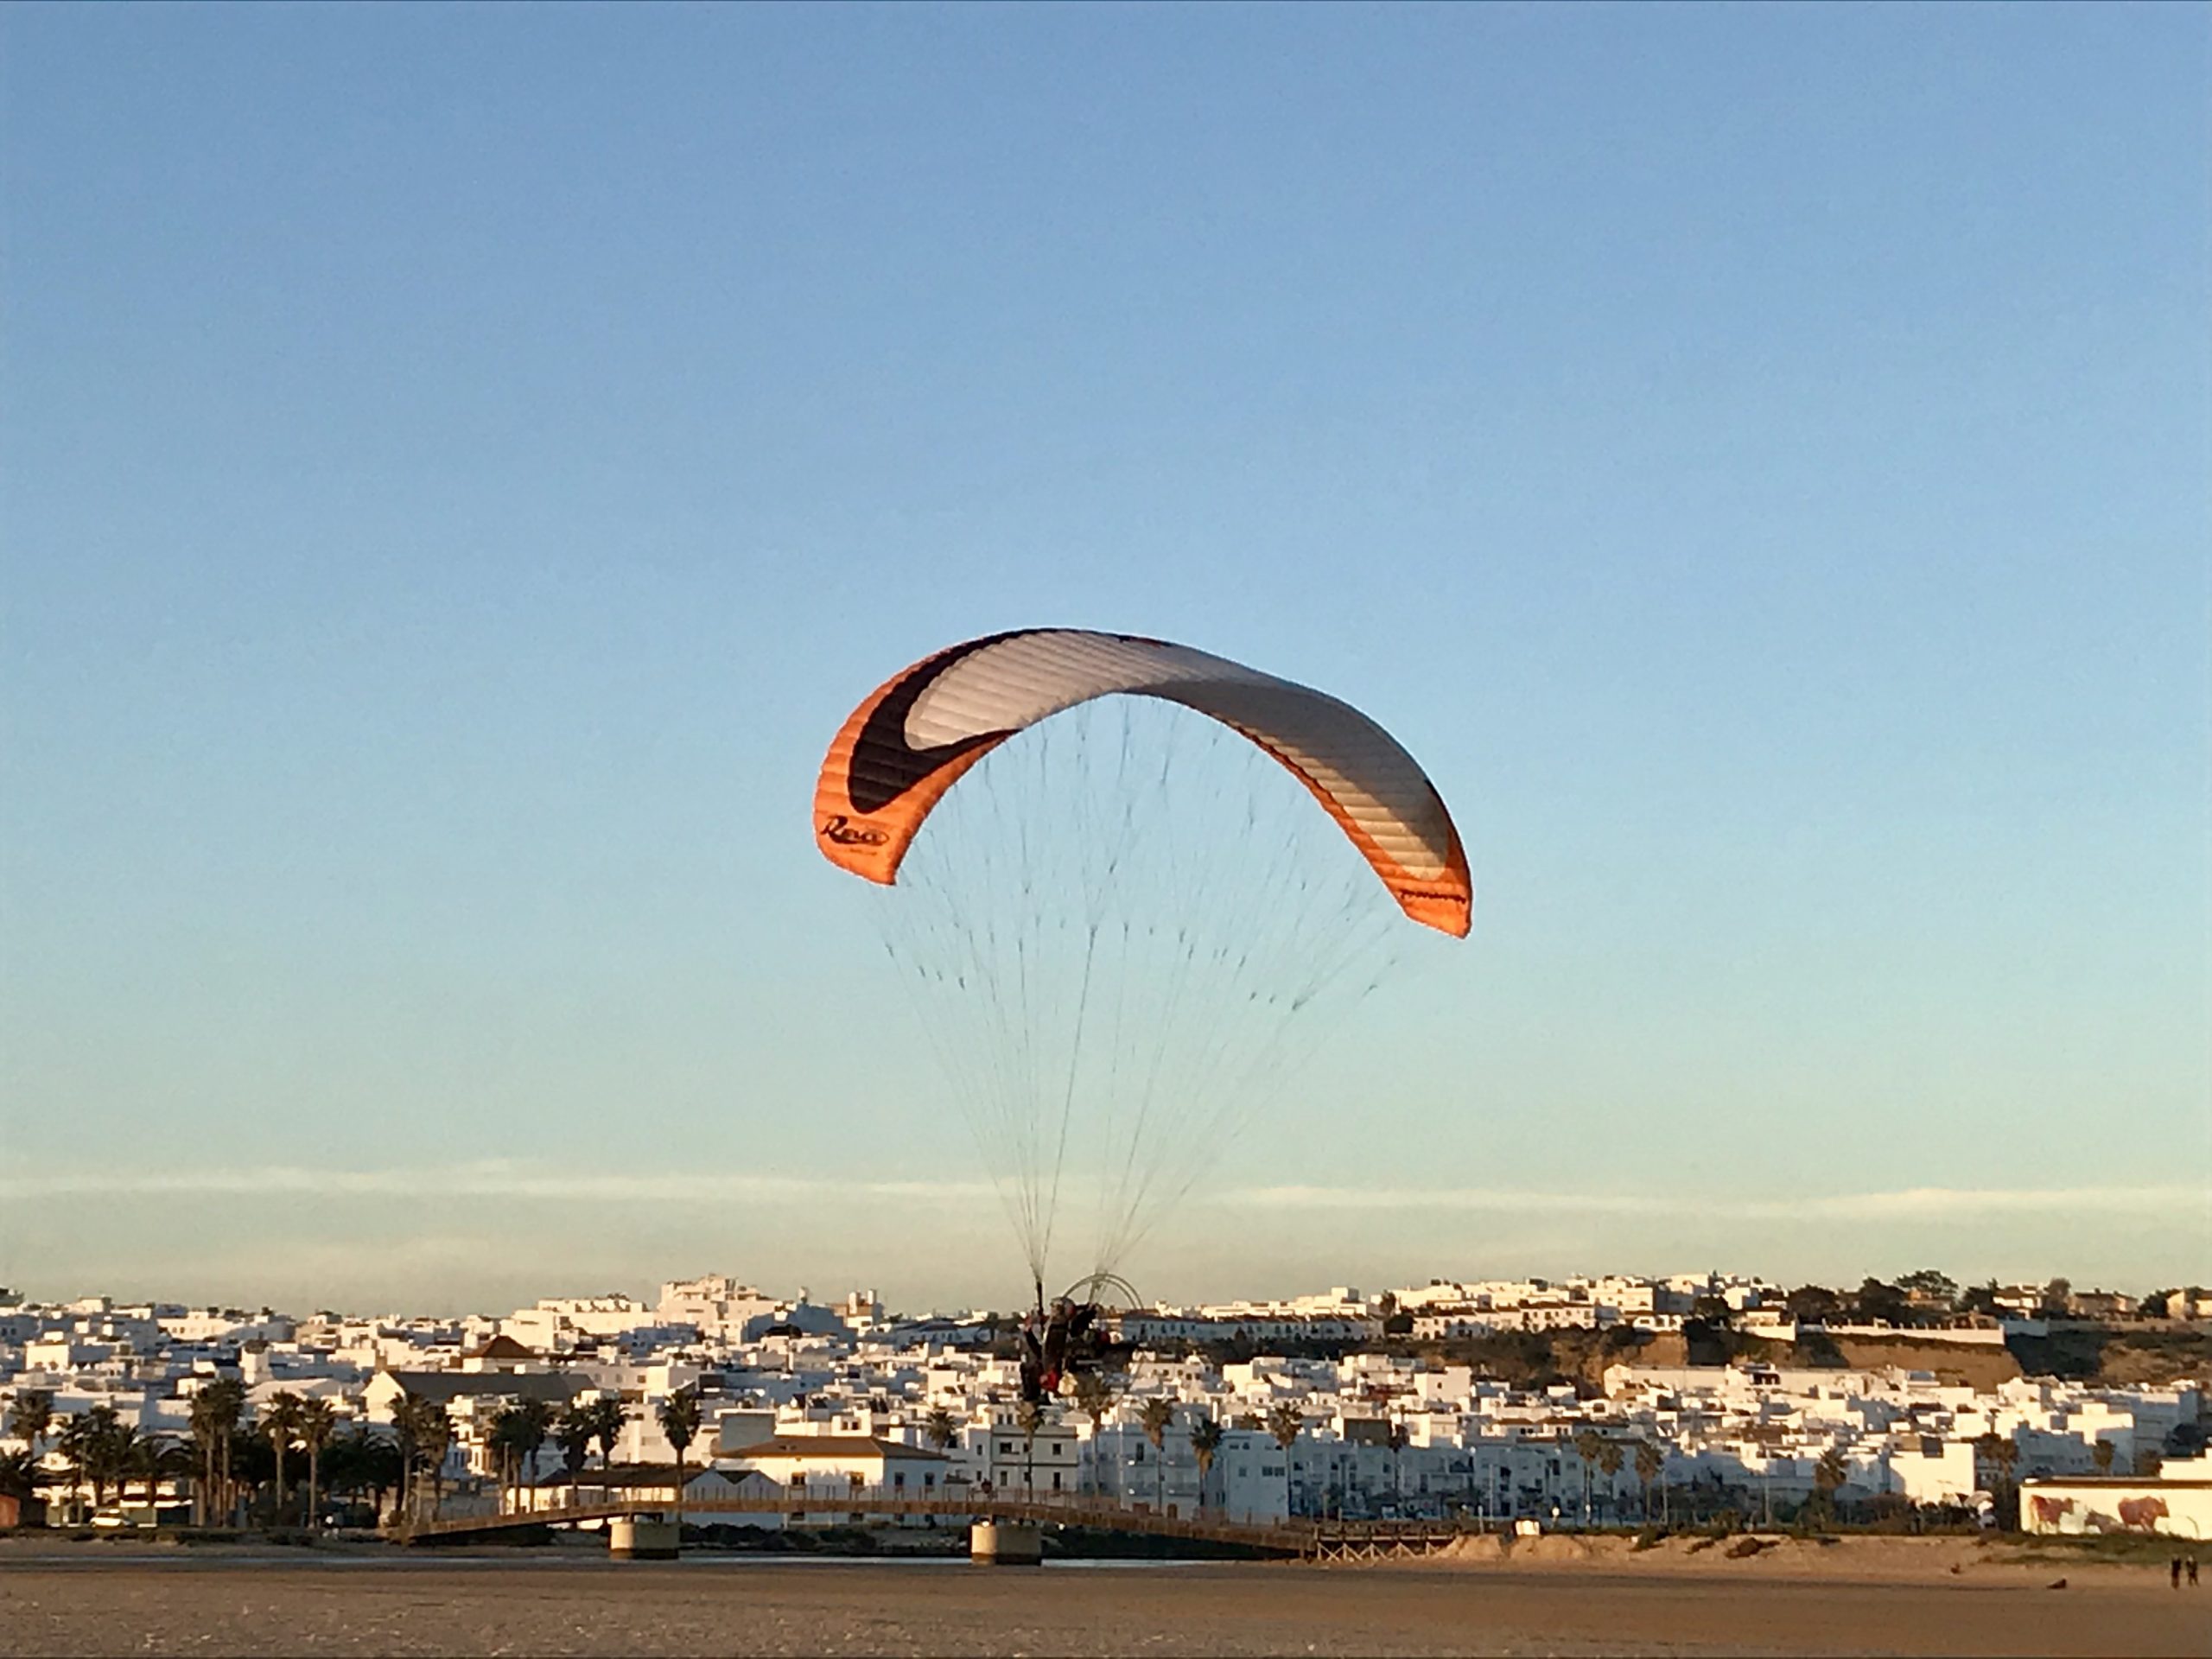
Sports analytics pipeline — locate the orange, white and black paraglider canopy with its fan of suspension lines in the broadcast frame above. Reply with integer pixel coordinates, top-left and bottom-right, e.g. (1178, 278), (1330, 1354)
(814, 628), (1473, 1309)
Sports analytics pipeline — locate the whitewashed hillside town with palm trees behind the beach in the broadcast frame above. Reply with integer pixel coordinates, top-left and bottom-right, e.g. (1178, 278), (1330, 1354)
(0, 1272), (2212, 1544)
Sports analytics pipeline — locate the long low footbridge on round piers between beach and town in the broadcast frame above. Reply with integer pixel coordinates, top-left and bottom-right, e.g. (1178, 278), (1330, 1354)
(387, 1489), (1462, 1561)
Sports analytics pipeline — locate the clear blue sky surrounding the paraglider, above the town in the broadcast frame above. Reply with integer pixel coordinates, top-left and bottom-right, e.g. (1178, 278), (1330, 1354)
(0, 7), (2212, 1307)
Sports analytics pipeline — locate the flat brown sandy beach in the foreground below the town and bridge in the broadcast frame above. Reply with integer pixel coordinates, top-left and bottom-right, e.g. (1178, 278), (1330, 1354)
(0, 1540), (2212, 1659)
